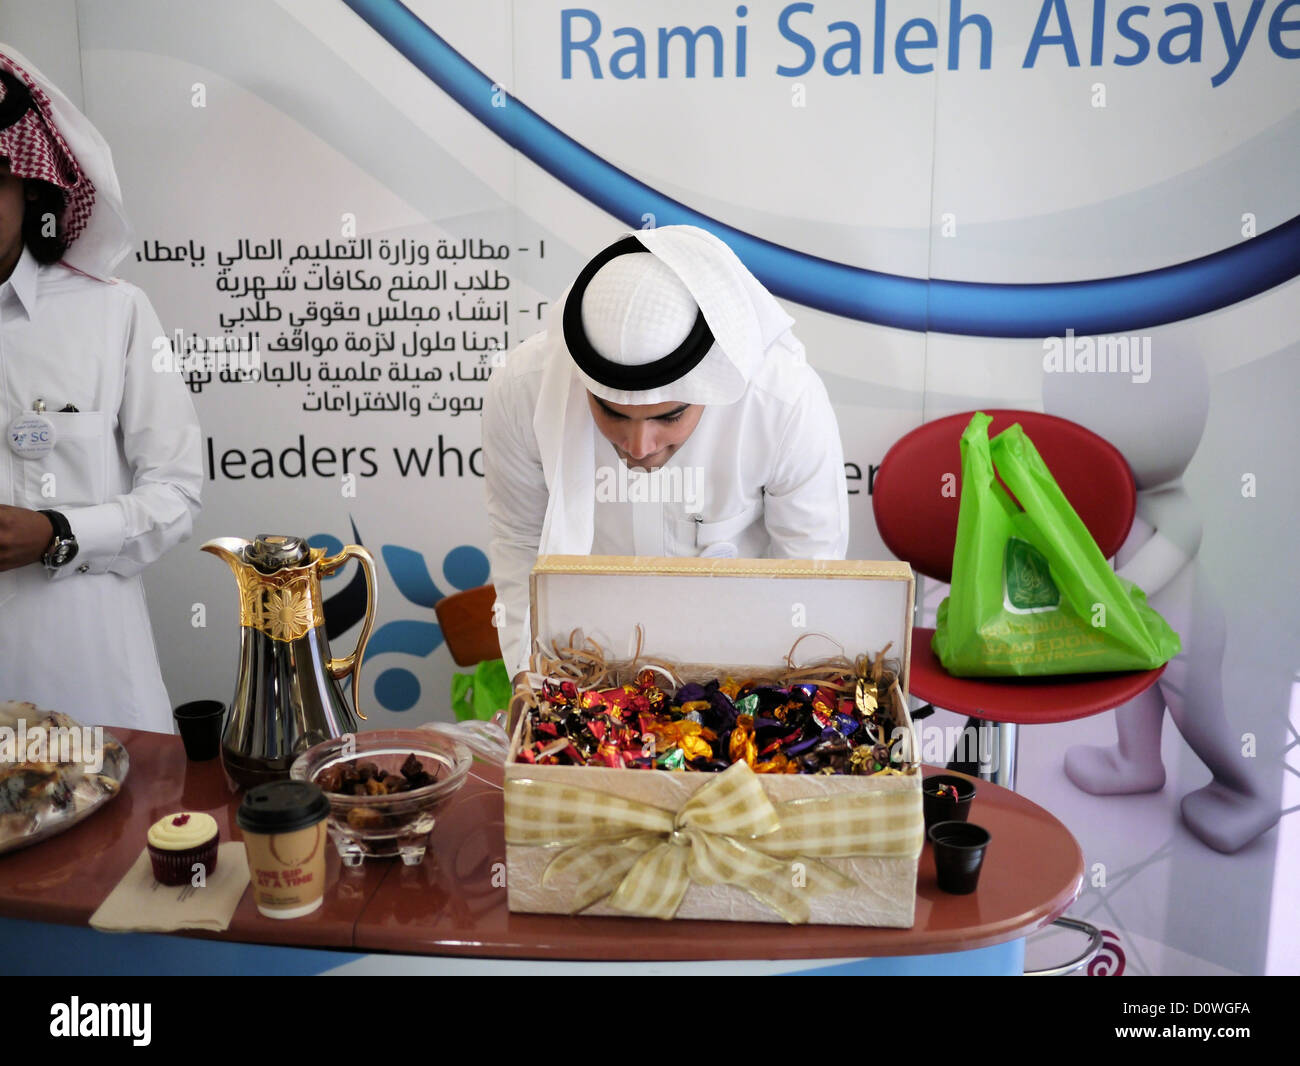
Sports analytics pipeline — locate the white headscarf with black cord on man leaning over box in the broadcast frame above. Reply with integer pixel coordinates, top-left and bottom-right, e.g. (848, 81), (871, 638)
(533, 226), (803, 555)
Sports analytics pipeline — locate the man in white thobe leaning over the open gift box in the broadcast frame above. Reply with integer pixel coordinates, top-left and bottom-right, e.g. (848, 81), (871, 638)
(484, 226), (849, 675)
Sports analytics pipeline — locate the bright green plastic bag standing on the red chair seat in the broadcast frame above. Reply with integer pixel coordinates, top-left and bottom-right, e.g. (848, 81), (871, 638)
(931, 412), (1182, 677)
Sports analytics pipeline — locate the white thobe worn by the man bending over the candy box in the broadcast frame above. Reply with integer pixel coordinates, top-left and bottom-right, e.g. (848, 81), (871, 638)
(484, 333), (849, 675)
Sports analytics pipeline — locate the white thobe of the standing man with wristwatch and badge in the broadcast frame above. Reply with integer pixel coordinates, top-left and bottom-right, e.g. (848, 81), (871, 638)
(0, 250), (203, 732)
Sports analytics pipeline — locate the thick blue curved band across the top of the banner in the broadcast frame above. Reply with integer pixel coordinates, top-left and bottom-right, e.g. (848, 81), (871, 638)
(343, 0), (1300, 337)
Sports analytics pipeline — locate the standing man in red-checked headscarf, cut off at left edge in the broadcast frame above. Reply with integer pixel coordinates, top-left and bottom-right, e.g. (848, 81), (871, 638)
(0, 46), (203, 732)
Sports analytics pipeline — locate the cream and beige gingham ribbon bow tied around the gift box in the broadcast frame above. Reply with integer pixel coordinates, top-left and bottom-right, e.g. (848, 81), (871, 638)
(506, 762), (923, 923)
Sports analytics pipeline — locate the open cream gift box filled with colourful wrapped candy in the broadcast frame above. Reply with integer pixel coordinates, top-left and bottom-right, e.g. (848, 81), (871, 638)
(506, 555), (923, 927)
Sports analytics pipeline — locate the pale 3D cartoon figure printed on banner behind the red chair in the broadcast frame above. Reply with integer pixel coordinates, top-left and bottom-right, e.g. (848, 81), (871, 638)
(1043, 338), (1279, 853)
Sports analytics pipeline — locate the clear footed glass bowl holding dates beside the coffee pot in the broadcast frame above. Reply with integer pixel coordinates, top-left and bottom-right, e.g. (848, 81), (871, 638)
(289, 729), (473, 866)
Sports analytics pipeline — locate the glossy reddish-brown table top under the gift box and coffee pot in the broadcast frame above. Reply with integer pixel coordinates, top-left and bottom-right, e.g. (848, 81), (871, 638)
(0, 729), (1083, 961)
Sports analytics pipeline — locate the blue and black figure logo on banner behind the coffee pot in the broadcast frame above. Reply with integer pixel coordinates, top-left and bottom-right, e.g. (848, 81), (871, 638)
(308, 523), (489, 711)
